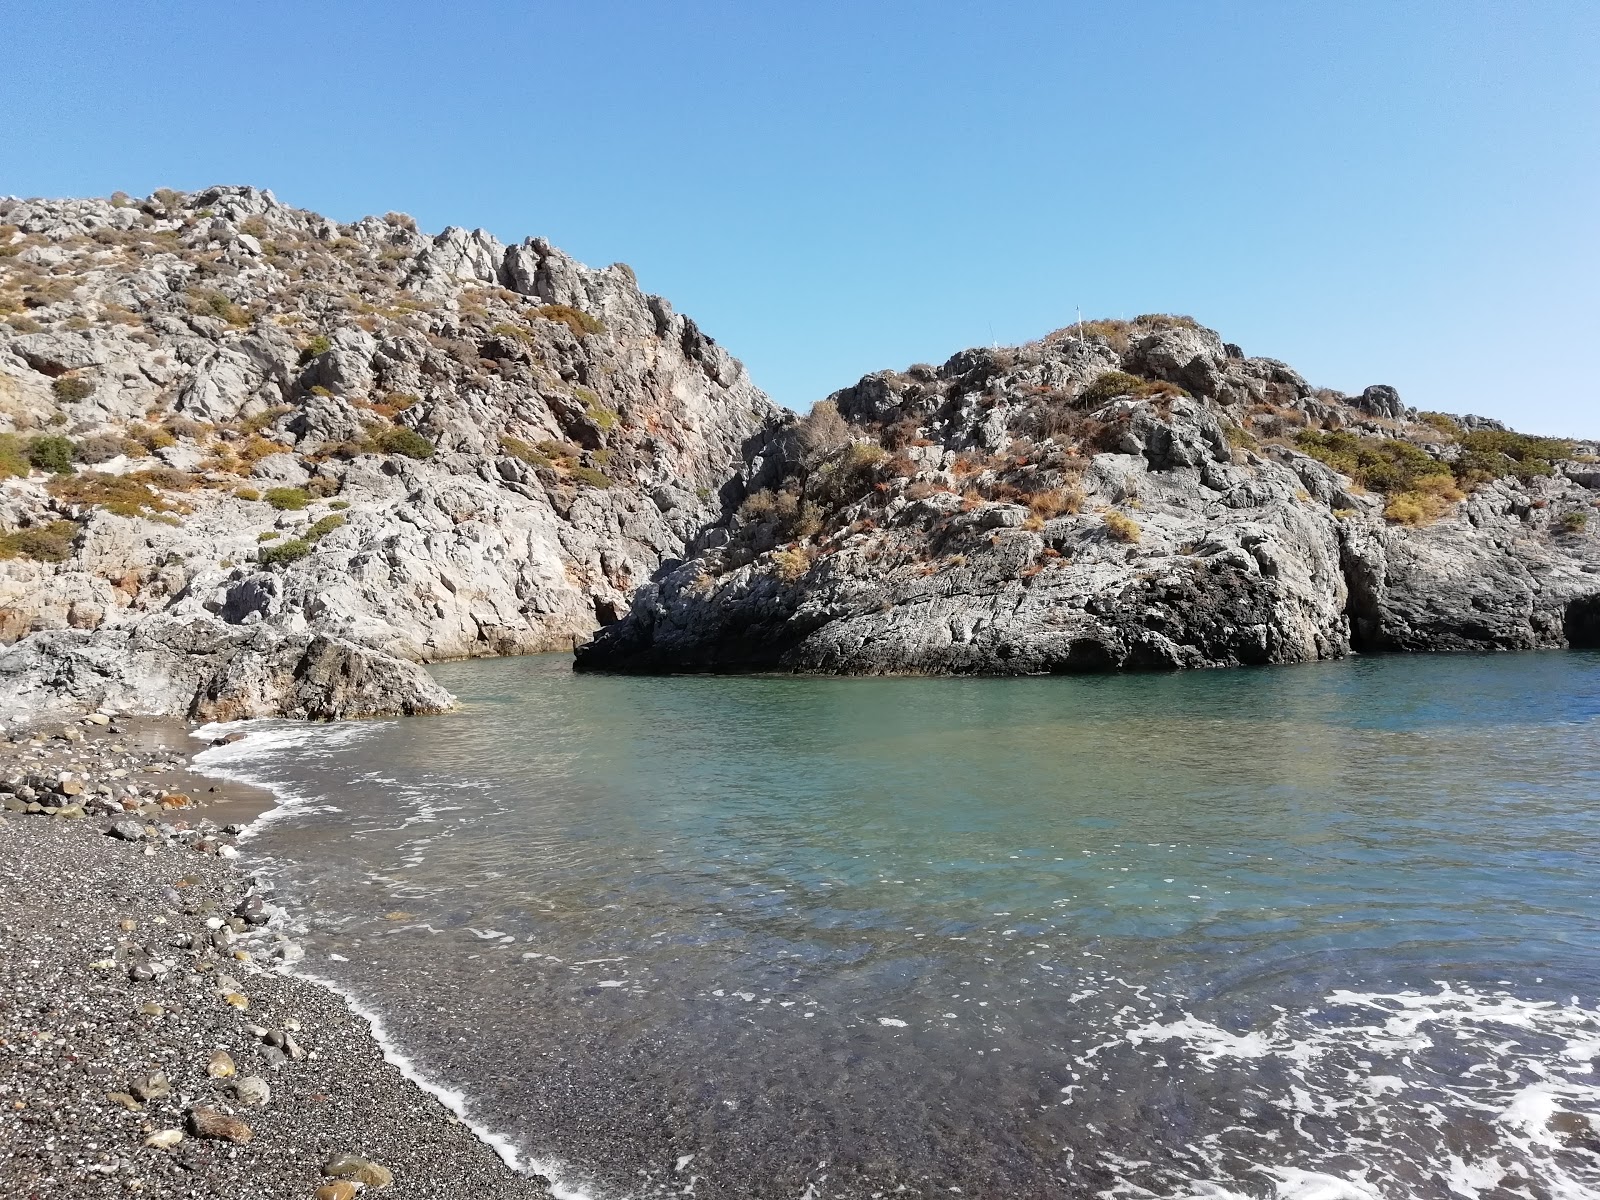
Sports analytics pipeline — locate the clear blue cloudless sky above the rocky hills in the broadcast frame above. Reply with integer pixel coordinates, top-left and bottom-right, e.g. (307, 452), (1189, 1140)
(9, 0), (1600, 435)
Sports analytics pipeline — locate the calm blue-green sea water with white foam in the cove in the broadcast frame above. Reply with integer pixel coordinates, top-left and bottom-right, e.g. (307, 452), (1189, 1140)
(203, 653), (1600, 1200)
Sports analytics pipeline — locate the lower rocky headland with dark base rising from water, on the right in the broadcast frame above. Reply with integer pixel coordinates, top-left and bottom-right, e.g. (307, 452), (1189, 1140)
(578, 317), (1600, 674)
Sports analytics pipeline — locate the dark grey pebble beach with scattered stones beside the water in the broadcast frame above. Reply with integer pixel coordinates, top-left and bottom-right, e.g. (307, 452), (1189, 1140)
(0, 714), (552, 1200)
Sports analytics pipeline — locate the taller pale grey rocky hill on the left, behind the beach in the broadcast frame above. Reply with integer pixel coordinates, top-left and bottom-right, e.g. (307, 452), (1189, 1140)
(0, 187), (781, 717)
